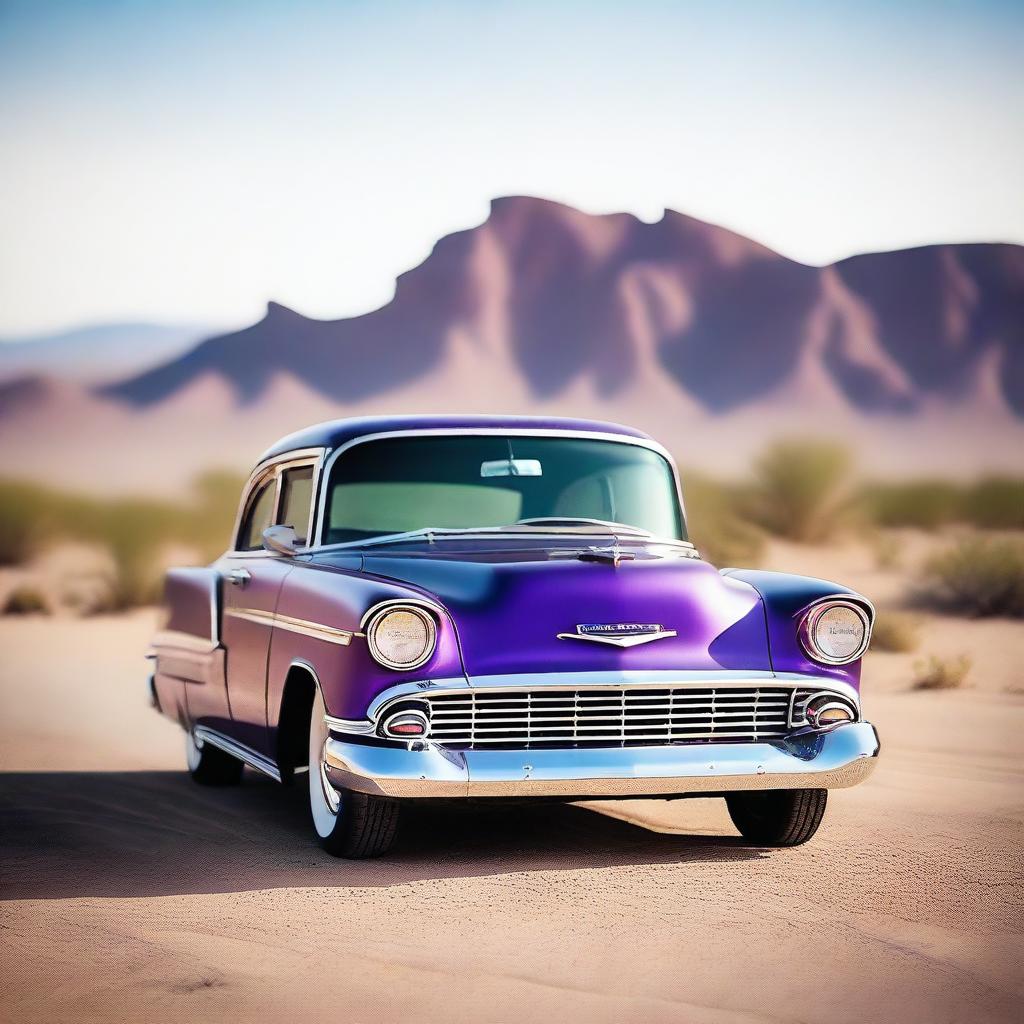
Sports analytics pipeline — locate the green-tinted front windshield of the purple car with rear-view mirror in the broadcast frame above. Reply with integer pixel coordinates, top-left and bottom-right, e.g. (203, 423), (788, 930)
(324, 435), (686, 544)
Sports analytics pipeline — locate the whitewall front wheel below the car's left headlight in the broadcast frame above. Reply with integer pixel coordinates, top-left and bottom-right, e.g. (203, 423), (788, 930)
(309, 688), (399, 859)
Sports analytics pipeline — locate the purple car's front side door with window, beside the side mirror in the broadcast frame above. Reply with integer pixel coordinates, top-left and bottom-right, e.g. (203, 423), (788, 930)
(221, 458), (316, 755)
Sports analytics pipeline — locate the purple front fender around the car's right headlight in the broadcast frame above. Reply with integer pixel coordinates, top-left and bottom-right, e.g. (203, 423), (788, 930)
(721, 569), (874, 690)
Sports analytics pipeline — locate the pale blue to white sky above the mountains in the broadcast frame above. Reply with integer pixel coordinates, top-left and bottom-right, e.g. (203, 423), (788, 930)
(0, 0), (1024, 338)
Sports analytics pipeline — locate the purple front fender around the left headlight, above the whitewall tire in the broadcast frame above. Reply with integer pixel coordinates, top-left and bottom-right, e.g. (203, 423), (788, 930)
(267, 556), (464, 729)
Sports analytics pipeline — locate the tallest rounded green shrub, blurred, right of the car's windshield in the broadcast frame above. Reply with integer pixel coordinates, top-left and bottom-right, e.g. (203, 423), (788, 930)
(745, 440), (853, 543)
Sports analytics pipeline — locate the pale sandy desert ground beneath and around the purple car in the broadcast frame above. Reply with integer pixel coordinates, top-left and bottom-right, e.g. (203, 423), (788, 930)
(0, 550), (1024, 1024)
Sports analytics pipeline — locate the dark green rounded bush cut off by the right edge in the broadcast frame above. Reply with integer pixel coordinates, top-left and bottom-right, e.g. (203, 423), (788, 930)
(918, 537), (1024, 618)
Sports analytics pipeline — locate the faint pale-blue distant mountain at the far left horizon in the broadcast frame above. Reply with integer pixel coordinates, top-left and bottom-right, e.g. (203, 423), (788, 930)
(0, 324), (210, 384)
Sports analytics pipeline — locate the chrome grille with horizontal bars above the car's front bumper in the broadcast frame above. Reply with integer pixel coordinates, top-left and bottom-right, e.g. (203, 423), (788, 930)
(425, 687), (793, 748)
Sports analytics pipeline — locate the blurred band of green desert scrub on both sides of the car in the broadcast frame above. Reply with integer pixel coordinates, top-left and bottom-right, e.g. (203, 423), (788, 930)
(0, 440), (1024, 618)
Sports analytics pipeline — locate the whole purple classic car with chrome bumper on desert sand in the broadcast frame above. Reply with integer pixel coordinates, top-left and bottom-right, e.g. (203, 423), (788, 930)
(150, 417), (879, 857)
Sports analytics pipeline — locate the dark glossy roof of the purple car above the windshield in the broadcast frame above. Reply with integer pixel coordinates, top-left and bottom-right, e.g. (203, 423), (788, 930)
(259, 416), (650, 462)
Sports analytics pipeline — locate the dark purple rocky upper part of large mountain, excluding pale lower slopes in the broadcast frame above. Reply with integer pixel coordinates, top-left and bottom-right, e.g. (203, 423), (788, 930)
(102, 198), (1024, 416)
